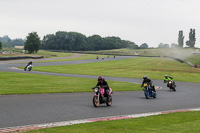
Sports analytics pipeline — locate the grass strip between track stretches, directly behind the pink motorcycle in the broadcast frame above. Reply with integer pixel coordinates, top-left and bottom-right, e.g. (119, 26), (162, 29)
(0, 72), (142, 95)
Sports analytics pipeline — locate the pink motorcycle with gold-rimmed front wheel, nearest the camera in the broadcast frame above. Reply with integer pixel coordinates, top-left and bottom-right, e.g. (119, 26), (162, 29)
(92, 86), (112, 107)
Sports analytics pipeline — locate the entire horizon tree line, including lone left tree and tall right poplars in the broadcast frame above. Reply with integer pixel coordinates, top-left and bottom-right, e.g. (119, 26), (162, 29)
(0, 29), (196, 53)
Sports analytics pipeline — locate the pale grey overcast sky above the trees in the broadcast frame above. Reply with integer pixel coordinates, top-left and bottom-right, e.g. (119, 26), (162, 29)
(0, 0), (200, 47)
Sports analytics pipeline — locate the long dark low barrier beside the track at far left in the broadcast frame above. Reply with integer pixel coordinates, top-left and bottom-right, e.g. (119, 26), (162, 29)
(0, 56), (44, 61)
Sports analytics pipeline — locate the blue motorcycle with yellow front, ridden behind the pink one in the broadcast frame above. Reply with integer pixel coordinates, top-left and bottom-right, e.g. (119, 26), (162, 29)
(144, 83), (157, 99)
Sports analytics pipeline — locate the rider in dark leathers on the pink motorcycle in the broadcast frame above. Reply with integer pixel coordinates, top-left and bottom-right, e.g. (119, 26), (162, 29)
(96, 76), (110, 97)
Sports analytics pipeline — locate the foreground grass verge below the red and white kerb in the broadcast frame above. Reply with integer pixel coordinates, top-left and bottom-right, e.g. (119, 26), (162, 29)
(25, 111), (200, 133)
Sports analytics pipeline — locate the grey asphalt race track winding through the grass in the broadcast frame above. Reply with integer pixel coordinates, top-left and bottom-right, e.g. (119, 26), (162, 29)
(0, 56), (200, 128)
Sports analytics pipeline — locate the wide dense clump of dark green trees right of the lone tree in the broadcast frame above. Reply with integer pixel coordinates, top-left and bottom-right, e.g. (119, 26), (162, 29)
(41, 31), (138, 51)
